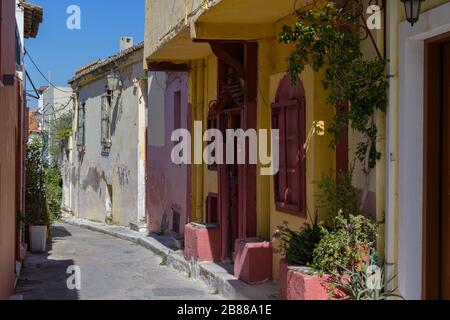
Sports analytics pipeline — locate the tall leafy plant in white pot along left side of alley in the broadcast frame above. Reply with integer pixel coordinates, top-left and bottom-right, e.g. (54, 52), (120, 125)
(24, 138), (49, 252)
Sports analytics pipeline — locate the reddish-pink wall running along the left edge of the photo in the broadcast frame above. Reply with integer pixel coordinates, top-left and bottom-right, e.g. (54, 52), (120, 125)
(0, 0), (20, 299)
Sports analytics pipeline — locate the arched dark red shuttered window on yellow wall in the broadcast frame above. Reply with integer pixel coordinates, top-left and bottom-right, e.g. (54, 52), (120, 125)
(272, 78), (306, 216)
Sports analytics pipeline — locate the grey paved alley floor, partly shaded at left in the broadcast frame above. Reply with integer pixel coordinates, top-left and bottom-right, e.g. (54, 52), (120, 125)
(16, 223), (222, 300)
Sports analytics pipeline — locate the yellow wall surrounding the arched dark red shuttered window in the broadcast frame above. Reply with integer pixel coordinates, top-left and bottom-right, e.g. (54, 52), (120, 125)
(268, 17), (336, 278)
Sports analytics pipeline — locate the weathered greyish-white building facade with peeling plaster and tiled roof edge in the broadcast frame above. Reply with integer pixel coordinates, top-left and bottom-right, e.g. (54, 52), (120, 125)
(63, 44), (147, 226)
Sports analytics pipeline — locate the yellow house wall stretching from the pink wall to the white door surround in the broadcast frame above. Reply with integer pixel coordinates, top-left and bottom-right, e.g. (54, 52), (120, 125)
(177, 0), (428, 276)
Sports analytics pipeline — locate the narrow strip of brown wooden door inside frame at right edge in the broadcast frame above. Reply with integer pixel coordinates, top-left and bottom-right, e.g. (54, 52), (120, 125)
(440, 42), (450, 299)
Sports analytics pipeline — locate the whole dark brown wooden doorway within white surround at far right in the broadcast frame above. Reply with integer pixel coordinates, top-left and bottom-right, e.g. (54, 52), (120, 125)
(423, 34), (450, 299)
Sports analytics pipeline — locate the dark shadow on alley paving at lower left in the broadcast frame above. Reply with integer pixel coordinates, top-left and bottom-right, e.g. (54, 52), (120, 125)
(16, 227), (80, 300)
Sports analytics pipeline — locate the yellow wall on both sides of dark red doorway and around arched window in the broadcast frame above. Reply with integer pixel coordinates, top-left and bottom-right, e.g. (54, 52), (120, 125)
(185, 16), (335, 277)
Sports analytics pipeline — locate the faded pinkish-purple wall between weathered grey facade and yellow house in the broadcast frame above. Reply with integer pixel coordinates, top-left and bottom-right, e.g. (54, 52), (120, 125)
(147, 73), (191, 234)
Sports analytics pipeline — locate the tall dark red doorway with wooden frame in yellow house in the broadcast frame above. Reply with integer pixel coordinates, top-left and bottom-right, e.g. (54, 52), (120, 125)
(209, 41), (257, 262)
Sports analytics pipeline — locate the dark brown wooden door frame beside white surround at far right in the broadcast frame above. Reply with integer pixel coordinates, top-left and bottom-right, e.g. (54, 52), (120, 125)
(422, 32), (450, 299)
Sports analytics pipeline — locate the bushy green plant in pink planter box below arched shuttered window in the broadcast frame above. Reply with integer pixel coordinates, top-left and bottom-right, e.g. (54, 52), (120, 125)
(276, 211), (377, 300)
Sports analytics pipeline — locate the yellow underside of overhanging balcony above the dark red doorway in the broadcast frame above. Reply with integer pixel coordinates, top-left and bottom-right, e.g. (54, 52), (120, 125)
(146, 0), (298, 63)
